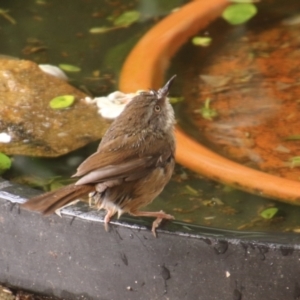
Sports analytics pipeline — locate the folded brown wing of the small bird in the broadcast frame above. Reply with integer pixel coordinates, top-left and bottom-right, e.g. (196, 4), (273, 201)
(74, 136), (173, 185)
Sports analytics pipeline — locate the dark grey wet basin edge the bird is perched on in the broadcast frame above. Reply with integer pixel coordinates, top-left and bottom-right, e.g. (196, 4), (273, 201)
(0, 180), (300, 300)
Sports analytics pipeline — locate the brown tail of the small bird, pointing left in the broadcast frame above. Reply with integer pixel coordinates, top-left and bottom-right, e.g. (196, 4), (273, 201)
(21, 184), (95, 215)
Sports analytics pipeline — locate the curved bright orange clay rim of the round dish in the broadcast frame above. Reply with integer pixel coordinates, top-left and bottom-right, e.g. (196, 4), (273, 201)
(120, 0), (300, 205)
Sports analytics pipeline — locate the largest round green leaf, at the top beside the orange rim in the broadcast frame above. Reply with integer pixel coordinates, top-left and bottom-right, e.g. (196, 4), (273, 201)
(222, 3), (257, 25)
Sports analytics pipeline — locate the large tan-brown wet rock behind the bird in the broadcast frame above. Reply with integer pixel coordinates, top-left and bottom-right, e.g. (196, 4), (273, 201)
(0, 59), (109, 157)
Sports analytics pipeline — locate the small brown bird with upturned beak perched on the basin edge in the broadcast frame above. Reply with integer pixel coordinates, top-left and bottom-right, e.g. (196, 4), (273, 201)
(22, 76), (175, 235)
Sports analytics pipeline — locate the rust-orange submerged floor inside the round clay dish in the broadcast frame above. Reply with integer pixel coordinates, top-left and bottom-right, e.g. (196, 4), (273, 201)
(185, 22), (300, 180)
